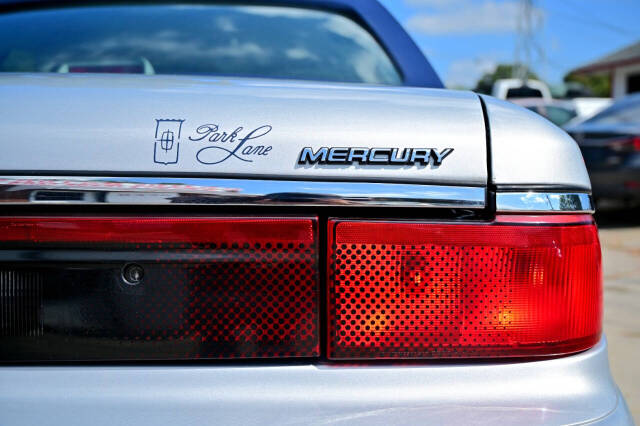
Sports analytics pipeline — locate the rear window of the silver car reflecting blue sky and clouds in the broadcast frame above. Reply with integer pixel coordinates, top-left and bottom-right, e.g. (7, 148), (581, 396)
(0, 4), (402, 85)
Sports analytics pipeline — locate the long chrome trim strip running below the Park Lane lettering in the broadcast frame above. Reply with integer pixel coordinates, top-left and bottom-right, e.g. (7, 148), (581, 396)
(0, 176), (486, 209)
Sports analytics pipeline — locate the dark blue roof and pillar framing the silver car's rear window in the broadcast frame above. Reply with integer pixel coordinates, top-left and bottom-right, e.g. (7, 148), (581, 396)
(0, 0), (444, 88)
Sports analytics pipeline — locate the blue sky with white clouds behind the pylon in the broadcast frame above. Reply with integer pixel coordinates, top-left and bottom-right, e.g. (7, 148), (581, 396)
(379, 0), (640, 88)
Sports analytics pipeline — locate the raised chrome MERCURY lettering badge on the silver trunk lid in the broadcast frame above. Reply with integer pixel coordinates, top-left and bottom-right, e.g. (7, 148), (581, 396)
(298, 147), (453, 166)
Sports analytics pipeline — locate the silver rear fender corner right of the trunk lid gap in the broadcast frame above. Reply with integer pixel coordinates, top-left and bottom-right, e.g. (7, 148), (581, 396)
(482, 96), (591, 192)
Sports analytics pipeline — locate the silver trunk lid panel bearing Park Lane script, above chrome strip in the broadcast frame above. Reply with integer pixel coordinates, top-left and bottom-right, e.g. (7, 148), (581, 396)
(0, 74), (487, 186)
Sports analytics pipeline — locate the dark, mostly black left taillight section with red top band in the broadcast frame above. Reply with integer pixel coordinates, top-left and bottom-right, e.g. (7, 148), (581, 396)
(0, 217), (319, 361)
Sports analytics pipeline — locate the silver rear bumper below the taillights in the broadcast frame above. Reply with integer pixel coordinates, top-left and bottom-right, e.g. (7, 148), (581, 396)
(0, 340), (631, 426)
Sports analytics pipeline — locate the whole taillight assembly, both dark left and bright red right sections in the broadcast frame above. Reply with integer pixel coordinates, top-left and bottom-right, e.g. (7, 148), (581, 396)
(0, 215), (602, 361)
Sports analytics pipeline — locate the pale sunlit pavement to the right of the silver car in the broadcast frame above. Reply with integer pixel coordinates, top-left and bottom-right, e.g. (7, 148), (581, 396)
(596, 209), (640, 422)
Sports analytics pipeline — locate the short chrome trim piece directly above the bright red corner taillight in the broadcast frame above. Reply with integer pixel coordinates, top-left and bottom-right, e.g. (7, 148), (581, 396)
(496, 191), (594, 213)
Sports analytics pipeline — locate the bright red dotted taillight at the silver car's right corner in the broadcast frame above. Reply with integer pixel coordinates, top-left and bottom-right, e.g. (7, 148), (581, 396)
(328, 216), (602, 360)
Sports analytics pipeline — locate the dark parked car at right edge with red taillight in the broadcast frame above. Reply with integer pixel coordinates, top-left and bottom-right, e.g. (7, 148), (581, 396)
(567, 94), (640, 207)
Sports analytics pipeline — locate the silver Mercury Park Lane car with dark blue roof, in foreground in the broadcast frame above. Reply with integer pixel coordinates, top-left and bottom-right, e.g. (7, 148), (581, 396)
(0, 0), (633, 426)
